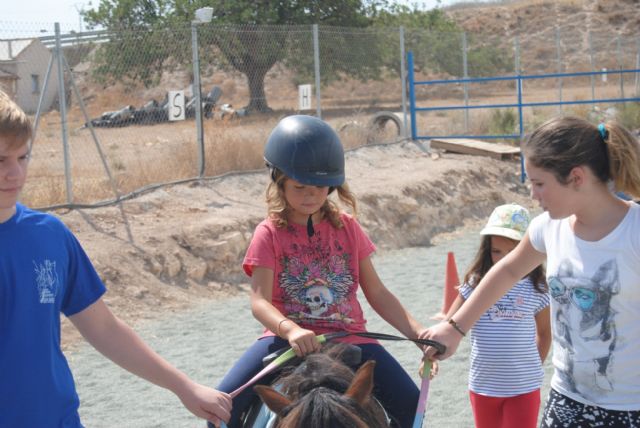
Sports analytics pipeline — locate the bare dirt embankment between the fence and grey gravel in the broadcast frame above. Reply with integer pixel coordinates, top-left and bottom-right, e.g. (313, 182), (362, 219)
(54, 142), (534, 347)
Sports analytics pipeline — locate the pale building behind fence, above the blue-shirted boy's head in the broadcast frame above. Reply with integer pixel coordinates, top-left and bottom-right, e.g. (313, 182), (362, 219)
(0, 39), (58, 113)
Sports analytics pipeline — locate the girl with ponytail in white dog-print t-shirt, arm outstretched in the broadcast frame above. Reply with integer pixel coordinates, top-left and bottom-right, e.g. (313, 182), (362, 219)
(422, 117), (640, 428)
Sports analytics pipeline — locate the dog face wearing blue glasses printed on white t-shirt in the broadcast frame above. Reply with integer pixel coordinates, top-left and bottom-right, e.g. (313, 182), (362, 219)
(549, 260), (620, 401)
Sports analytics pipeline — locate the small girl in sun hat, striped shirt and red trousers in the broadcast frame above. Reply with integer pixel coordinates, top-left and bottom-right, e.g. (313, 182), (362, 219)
(447, 204), (551, 428)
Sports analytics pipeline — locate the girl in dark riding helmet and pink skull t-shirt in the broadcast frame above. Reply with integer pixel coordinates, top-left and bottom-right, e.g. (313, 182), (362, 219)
(219, 115), (430, 428)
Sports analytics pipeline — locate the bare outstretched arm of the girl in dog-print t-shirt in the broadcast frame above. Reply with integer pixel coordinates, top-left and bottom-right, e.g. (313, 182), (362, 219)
(423, 235), (545, 360)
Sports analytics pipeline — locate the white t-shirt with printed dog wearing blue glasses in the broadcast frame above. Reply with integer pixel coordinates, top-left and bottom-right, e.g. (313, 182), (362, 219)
(529, 203), (640, 410)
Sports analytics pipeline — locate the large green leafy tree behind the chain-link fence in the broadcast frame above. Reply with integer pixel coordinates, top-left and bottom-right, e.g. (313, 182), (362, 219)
(85, 0), (386, 112)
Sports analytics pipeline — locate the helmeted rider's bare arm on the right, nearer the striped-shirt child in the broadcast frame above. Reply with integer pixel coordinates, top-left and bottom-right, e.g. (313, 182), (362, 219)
(360, 257), (424, 339)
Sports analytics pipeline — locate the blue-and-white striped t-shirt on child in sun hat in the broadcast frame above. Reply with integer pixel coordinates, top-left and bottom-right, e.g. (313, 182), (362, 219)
(460, 278), (549, 397)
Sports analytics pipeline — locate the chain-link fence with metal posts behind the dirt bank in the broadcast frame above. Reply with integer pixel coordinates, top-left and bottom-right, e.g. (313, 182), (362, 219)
(0, 21), (640, 207)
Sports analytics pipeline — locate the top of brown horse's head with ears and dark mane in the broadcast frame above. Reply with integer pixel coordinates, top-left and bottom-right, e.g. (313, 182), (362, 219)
(254, 344), (389, 428)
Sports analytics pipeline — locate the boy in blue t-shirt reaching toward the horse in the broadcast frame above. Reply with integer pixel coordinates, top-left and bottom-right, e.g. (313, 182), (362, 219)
(0, 91), (231, 428)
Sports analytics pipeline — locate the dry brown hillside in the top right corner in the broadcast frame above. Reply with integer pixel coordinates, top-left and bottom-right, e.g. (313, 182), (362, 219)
(445, 0), (640, 71)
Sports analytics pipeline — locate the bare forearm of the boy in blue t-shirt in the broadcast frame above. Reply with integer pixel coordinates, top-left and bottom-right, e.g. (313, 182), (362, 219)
(69, 299), (231, 425)
